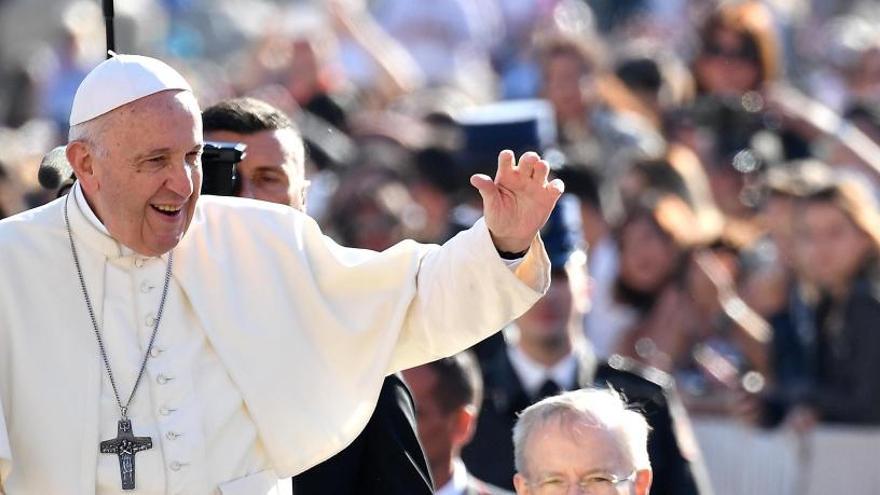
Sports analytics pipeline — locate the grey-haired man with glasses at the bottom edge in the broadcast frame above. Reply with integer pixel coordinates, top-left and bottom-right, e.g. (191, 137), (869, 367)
(513, 389), (652, 495)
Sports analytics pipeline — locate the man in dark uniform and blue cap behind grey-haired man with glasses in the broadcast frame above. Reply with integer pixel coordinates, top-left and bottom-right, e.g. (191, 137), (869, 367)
(462, 198), (710, 495)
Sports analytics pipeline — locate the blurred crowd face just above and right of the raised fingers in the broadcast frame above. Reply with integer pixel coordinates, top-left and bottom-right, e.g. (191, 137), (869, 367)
(544, 54), (592, 122)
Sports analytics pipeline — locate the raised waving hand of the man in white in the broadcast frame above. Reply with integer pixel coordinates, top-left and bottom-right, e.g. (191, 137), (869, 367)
(471, 150), (565, 253)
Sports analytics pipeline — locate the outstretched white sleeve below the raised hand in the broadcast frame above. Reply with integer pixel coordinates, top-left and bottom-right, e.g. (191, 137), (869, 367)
(388, 219), (550, 372)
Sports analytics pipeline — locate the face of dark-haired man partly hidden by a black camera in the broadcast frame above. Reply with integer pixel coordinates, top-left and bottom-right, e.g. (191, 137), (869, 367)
(206, 129), (308, 211)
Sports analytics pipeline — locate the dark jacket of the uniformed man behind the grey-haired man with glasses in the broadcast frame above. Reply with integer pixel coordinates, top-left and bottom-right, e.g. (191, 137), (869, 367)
(462, 351), (708, 495)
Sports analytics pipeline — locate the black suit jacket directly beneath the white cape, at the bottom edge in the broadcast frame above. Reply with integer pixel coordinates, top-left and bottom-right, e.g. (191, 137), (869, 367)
(293, 375), (433, 495)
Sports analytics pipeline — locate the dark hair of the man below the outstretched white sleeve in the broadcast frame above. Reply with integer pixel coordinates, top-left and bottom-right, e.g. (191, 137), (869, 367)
(427, 351), (483, 413)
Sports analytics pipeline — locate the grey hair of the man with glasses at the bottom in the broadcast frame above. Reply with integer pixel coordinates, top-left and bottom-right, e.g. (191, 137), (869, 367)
(513, 388), (651, 474)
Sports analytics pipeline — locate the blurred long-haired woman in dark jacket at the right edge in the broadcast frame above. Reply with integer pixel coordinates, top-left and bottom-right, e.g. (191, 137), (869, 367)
(778, 175), (880, 431)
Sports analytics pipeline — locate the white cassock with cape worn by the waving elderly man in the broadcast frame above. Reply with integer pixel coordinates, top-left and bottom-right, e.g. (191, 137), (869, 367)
(0, 184), (549, 495)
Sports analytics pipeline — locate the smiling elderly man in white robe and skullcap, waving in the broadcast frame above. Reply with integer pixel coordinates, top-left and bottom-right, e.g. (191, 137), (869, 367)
(0, 55), (563, 495)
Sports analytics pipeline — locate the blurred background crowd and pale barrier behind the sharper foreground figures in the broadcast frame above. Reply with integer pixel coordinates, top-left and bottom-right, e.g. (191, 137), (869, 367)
(0, 0), (880, 494)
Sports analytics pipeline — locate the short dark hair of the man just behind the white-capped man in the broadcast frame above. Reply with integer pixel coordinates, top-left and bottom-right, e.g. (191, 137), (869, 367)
(202, 97), (296, 134)
